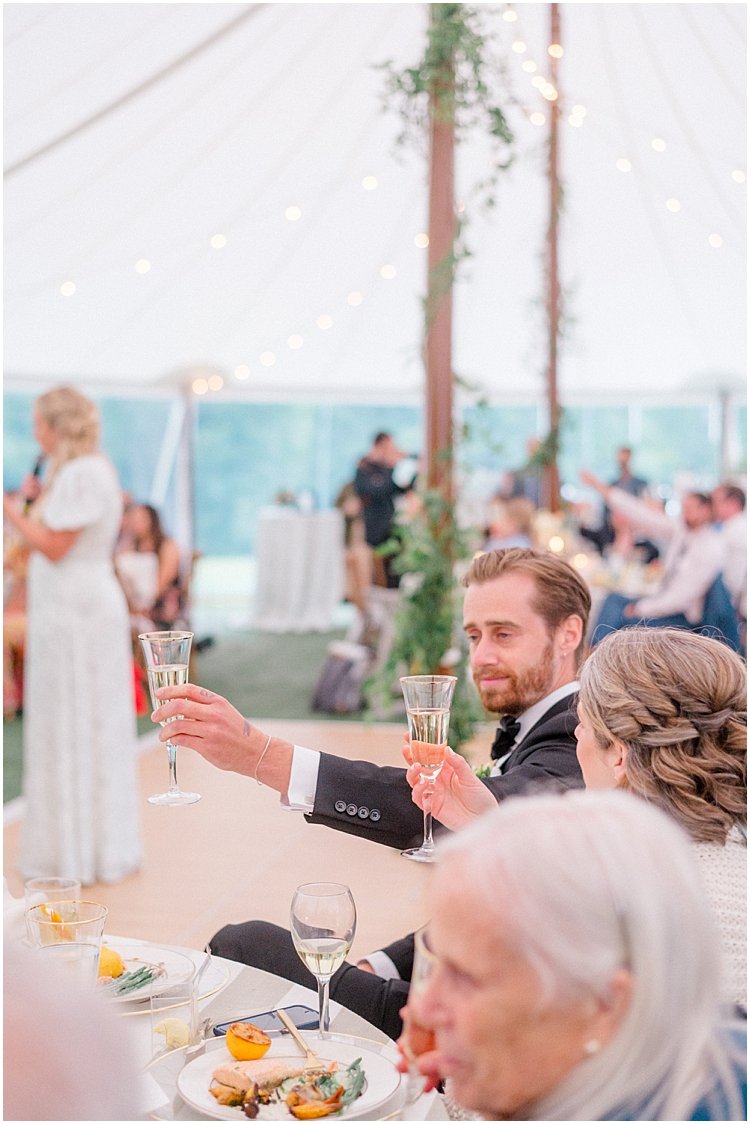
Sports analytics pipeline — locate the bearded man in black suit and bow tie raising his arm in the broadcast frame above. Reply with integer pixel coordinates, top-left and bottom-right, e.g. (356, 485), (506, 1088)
(154, 547), (590, 1036)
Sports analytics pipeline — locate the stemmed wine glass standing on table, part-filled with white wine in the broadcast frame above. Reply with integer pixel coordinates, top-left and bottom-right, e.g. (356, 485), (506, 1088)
(290, 882), (356, 1039)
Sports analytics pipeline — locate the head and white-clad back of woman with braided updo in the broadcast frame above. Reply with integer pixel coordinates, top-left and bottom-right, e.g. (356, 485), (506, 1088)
(576, 628), (748, 1008)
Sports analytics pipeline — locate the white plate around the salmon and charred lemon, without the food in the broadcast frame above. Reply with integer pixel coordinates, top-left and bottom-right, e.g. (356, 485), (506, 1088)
(177, 1034), (401, 1122)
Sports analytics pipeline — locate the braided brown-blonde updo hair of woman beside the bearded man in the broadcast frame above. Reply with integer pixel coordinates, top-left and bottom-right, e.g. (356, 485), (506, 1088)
(579, 628), (748, 844)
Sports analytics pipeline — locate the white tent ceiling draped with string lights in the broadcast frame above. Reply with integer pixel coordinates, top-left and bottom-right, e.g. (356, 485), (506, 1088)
(4, 3), (747, 402)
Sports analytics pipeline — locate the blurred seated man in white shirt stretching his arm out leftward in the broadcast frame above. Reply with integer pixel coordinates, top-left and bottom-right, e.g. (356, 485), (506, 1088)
(581, 472), (735, 644)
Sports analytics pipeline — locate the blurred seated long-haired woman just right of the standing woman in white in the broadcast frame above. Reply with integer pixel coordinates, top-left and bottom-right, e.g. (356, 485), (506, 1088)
(115, 504), (184, 632)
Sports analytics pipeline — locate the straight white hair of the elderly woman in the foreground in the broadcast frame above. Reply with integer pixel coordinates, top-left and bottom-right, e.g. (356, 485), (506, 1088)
(439, 791), (744, 1121)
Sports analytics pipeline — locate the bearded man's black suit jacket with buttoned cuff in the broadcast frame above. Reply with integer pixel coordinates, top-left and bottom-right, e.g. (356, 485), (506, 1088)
(306, 697), (584, 849)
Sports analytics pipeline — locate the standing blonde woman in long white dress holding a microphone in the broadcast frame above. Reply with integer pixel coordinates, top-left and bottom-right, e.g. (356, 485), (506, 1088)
(3, 387), (141, 885)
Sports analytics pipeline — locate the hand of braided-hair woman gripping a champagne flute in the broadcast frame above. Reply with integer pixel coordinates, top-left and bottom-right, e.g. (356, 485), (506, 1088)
(401, 734), (497, 831)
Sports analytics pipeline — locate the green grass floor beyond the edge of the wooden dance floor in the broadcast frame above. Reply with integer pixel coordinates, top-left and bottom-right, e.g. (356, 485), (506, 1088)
(2, 629), (355, 803)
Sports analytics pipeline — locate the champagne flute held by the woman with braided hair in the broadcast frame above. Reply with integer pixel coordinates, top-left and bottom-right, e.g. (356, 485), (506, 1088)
(401, 676), (457, 862)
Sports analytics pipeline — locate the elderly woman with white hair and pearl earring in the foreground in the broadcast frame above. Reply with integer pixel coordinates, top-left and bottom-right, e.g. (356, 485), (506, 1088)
(403, 792), (747, 1121)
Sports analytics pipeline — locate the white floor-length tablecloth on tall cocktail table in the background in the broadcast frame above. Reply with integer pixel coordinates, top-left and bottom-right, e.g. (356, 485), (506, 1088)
(253, 507), (344, 633)
